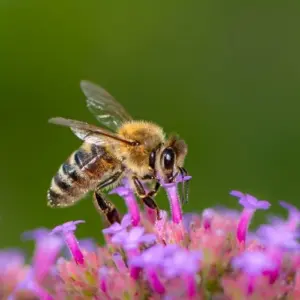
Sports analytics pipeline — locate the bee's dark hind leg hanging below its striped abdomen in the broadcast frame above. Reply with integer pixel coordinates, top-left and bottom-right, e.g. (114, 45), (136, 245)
(93, 172), (123, 224)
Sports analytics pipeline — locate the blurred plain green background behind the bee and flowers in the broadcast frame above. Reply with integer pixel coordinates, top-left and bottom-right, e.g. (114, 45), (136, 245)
(0, 0), (300, 247)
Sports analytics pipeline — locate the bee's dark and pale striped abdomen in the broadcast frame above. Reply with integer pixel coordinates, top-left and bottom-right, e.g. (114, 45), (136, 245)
(48, 144), (120, 207)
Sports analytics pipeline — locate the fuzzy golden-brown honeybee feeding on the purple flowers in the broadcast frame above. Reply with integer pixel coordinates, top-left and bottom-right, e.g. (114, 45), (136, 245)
(47, 81), (187, 224)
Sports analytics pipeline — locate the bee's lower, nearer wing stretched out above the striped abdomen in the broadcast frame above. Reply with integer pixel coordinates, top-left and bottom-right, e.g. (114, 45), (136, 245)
(49, 118), (137, 146)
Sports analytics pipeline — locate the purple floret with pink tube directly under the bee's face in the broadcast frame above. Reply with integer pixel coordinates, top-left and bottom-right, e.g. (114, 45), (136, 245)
(160, 176), (192, 224)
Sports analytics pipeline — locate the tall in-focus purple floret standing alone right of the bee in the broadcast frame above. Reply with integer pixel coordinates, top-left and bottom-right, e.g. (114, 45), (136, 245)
(230, 191), (270, 243)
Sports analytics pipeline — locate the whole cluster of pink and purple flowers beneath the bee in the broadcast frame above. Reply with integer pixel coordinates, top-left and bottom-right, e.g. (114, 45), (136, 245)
(0, 177), (300, 300)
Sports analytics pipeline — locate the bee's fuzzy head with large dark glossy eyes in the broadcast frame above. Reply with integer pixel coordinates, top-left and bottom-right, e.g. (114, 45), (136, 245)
(149, 137), (187, 183)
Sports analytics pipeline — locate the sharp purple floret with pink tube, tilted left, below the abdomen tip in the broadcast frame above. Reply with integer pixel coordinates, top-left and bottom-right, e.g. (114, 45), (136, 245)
(51, 220), (84, 265)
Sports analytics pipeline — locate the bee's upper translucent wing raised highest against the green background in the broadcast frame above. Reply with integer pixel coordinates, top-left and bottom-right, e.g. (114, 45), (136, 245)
(80, 80), (132, 131)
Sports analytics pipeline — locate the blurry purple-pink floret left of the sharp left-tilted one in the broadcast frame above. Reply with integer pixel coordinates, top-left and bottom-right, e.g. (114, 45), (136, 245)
(23, 228), (63, 282)
